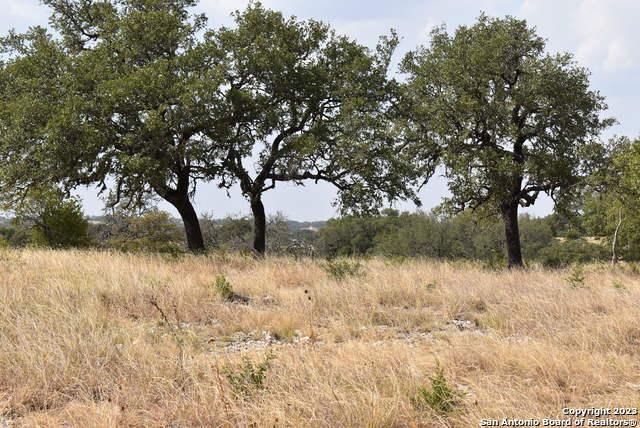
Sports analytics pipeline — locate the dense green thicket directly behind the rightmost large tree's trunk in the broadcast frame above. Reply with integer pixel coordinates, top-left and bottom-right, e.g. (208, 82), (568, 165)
(318, 212), (553, 266)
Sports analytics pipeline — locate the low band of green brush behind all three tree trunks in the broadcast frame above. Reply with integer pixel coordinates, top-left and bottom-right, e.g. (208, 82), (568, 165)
(0, 188), (620, 268)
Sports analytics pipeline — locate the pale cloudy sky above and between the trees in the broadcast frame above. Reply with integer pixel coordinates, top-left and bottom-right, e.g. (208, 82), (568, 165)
(0, 0), (640, 221)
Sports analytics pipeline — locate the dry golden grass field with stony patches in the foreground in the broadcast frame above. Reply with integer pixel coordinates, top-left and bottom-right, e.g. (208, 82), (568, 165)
(0, 250), (640, 428)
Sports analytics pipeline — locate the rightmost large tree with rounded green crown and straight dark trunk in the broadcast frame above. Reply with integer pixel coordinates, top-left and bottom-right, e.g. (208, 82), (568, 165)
(401, 15), (612, 267)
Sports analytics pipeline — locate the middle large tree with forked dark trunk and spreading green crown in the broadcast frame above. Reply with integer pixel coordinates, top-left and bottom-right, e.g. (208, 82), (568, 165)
(198, 3), (422, 253)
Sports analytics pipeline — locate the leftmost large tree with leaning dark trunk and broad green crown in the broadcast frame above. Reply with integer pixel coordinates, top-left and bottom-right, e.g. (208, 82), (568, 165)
(0, 0), (220, 251)
